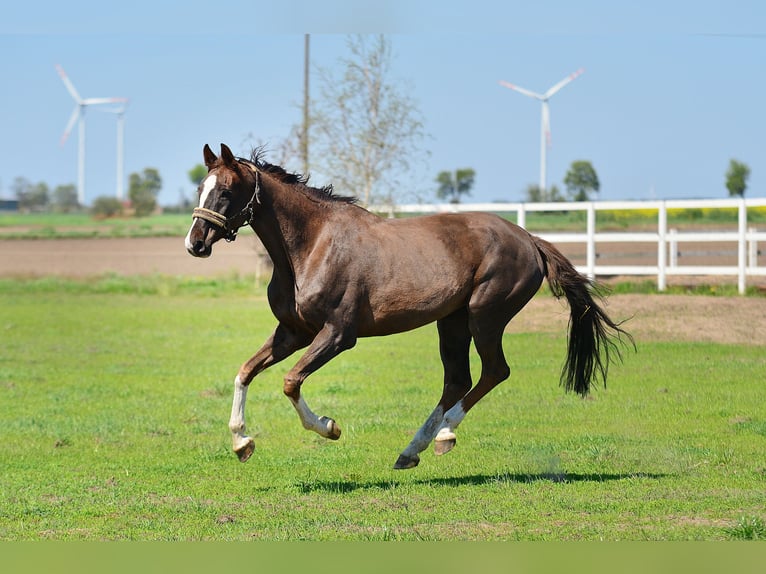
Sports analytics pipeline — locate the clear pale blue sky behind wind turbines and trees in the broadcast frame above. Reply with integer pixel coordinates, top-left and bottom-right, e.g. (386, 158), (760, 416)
(0, 0), (766, 205)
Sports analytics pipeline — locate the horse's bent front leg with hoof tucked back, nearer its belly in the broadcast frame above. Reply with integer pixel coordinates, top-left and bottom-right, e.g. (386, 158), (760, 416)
(283, 324), (356, 440)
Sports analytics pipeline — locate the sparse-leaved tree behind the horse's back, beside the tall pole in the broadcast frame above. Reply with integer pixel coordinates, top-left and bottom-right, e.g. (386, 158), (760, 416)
(309, 35), (432, 205)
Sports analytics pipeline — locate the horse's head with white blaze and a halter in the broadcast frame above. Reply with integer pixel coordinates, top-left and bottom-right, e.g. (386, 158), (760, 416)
(186, 144), (259, 257)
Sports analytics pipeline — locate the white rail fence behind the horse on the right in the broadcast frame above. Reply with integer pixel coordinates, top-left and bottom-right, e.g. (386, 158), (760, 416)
(375, 198), (766, 293)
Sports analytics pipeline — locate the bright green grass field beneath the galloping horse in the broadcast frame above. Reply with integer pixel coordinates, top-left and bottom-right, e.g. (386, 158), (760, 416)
(0, 281), (766, 541)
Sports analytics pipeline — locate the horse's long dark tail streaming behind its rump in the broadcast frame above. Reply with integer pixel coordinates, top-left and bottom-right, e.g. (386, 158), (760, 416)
(532, 236), (635, 397)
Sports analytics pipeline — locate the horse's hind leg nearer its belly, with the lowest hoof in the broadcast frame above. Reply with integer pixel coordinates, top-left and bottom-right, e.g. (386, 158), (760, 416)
(394, 308), (471, 469)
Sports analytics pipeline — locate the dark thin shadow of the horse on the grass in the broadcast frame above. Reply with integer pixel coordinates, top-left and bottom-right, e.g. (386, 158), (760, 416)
(296, 472), (667, 494)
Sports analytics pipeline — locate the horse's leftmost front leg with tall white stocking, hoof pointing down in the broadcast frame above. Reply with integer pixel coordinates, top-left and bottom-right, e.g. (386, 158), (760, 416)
(229, 325), (311, 462)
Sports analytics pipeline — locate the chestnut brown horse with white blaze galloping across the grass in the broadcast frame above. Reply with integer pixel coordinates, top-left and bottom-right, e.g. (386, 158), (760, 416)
(185, 144), (632, 469)
